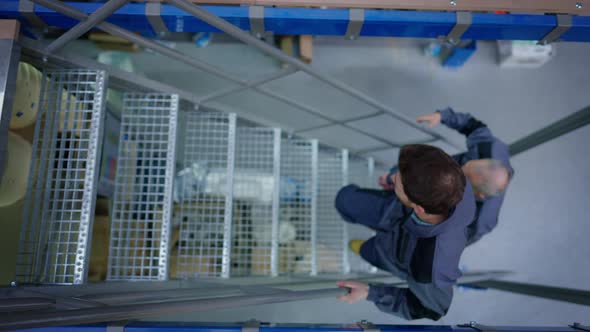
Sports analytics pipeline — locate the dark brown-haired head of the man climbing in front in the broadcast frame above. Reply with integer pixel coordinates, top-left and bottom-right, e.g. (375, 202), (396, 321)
(394, 144), (466, 216)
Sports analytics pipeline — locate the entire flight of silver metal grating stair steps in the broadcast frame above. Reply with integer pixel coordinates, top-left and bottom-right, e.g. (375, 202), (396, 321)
(19, 70), (386, 284)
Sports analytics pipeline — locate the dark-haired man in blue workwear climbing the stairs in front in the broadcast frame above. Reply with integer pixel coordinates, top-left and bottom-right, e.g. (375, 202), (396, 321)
(336, 144), (475, 320)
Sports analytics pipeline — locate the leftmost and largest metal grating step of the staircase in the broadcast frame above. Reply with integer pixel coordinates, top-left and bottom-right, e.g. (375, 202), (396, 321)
(17, 70), (107, 284)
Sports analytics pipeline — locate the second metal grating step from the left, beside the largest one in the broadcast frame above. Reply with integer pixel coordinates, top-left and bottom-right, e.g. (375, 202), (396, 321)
(107, 93), (178, 280)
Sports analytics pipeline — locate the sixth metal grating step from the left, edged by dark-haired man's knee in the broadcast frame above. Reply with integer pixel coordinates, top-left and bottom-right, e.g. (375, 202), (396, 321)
(316, 148), (348, 273)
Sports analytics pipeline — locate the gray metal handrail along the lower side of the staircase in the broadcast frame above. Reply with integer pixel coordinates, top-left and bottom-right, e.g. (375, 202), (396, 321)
(0, 271), (506, 330)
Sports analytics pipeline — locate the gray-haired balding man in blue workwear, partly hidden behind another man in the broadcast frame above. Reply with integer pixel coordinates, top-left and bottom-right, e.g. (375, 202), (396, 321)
(379, 108), (514, 245)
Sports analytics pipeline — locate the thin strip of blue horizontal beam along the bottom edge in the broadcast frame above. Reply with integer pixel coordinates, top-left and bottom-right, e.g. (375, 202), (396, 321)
(13, 322), (576, 332)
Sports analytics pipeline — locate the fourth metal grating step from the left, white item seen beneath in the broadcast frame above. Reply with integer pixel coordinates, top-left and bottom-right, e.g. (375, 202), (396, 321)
(231, 128), (280, 276)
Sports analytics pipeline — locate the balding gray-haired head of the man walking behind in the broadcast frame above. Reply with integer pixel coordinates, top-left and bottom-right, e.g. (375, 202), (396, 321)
(463, 159), (510, 199)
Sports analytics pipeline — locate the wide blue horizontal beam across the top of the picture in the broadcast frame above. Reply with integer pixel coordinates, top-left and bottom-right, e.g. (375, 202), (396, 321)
(0, 0), (590, 42)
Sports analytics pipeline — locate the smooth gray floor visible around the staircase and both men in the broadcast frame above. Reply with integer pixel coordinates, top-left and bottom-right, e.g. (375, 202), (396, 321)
(61, 38), (590, 326)
